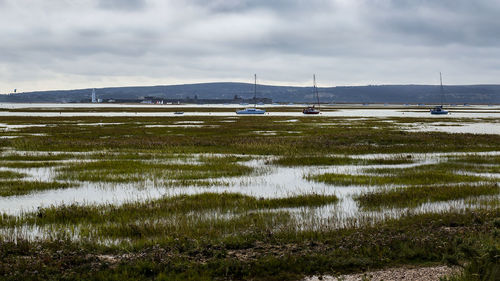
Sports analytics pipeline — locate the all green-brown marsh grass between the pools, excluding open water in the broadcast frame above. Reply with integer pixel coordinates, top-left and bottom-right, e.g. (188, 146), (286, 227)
(0, 112), (500, 281)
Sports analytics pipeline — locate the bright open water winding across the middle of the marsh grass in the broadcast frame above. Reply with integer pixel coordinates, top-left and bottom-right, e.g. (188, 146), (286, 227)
(0, 152), (500, 216)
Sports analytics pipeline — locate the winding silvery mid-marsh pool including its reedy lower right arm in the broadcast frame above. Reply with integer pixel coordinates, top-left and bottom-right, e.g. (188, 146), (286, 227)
(0, 152), (500, 227)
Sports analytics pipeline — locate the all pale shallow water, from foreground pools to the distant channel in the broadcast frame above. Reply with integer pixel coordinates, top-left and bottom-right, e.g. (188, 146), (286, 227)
(0, 104), (500, 234)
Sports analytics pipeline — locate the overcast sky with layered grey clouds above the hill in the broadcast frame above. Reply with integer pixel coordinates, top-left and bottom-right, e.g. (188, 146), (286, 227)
(0, 0), (500, 93)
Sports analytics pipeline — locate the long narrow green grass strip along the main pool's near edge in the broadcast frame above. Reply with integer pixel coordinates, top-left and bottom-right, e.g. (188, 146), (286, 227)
(7, 193), (338, 225)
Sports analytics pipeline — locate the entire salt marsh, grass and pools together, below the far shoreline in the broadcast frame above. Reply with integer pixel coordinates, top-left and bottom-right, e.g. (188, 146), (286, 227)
(0, 105), (500, 278)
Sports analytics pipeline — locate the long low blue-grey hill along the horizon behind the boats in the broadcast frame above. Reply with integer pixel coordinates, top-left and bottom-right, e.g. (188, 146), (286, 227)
(0, 82), (500, 104)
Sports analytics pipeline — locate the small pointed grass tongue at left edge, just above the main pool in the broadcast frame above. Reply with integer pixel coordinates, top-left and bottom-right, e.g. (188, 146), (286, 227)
(0, 180), (75, 197)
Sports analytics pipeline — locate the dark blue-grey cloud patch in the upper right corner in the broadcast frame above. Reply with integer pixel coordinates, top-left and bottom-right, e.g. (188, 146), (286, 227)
(365, 0), (500, 46)
